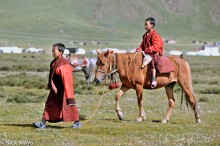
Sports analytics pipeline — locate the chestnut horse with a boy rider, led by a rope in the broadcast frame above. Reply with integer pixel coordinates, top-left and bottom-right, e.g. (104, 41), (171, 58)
(94, 50), (201, 123)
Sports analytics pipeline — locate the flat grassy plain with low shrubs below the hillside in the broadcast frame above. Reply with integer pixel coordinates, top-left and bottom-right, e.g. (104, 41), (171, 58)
(0, 54), (220, 146)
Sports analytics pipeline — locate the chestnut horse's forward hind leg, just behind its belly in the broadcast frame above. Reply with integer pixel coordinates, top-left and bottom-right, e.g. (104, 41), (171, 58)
(162, 82), (176, 123)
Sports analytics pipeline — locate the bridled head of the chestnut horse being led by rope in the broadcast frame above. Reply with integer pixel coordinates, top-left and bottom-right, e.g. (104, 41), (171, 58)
(94, 50), (114, 83)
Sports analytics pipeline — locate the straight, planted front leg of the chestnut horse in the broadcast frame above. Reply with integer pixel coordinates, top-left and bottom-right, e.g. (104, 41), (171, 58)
(136, 84), (146, 122)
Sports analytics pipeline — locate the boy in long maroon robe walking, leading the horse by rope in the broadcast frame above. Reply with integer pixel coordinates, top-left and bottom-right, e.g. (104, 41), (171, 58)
(33, 43), (81, 128)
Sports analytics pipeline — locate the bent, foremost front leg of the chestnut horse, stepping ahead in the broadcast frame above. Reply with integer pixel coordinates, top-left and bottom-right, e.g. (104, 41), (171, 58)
(115, 85), (129, 120)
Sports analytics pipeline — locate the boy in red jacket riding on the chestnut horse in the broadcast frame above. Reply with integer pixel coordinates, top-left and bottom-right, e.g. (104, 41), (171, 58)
(136, 17), (163, 88)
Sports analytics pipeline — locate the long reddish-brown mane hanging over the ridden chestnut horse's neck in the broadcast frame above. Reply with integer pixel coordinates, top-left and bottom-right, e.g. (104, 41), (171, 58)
(116, 52), (143, 78)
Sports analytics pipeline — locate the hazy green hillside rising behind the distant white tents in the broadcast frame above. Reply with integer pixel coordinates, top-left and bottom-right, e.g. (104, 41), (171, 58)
(0, 0), (220, 47)
